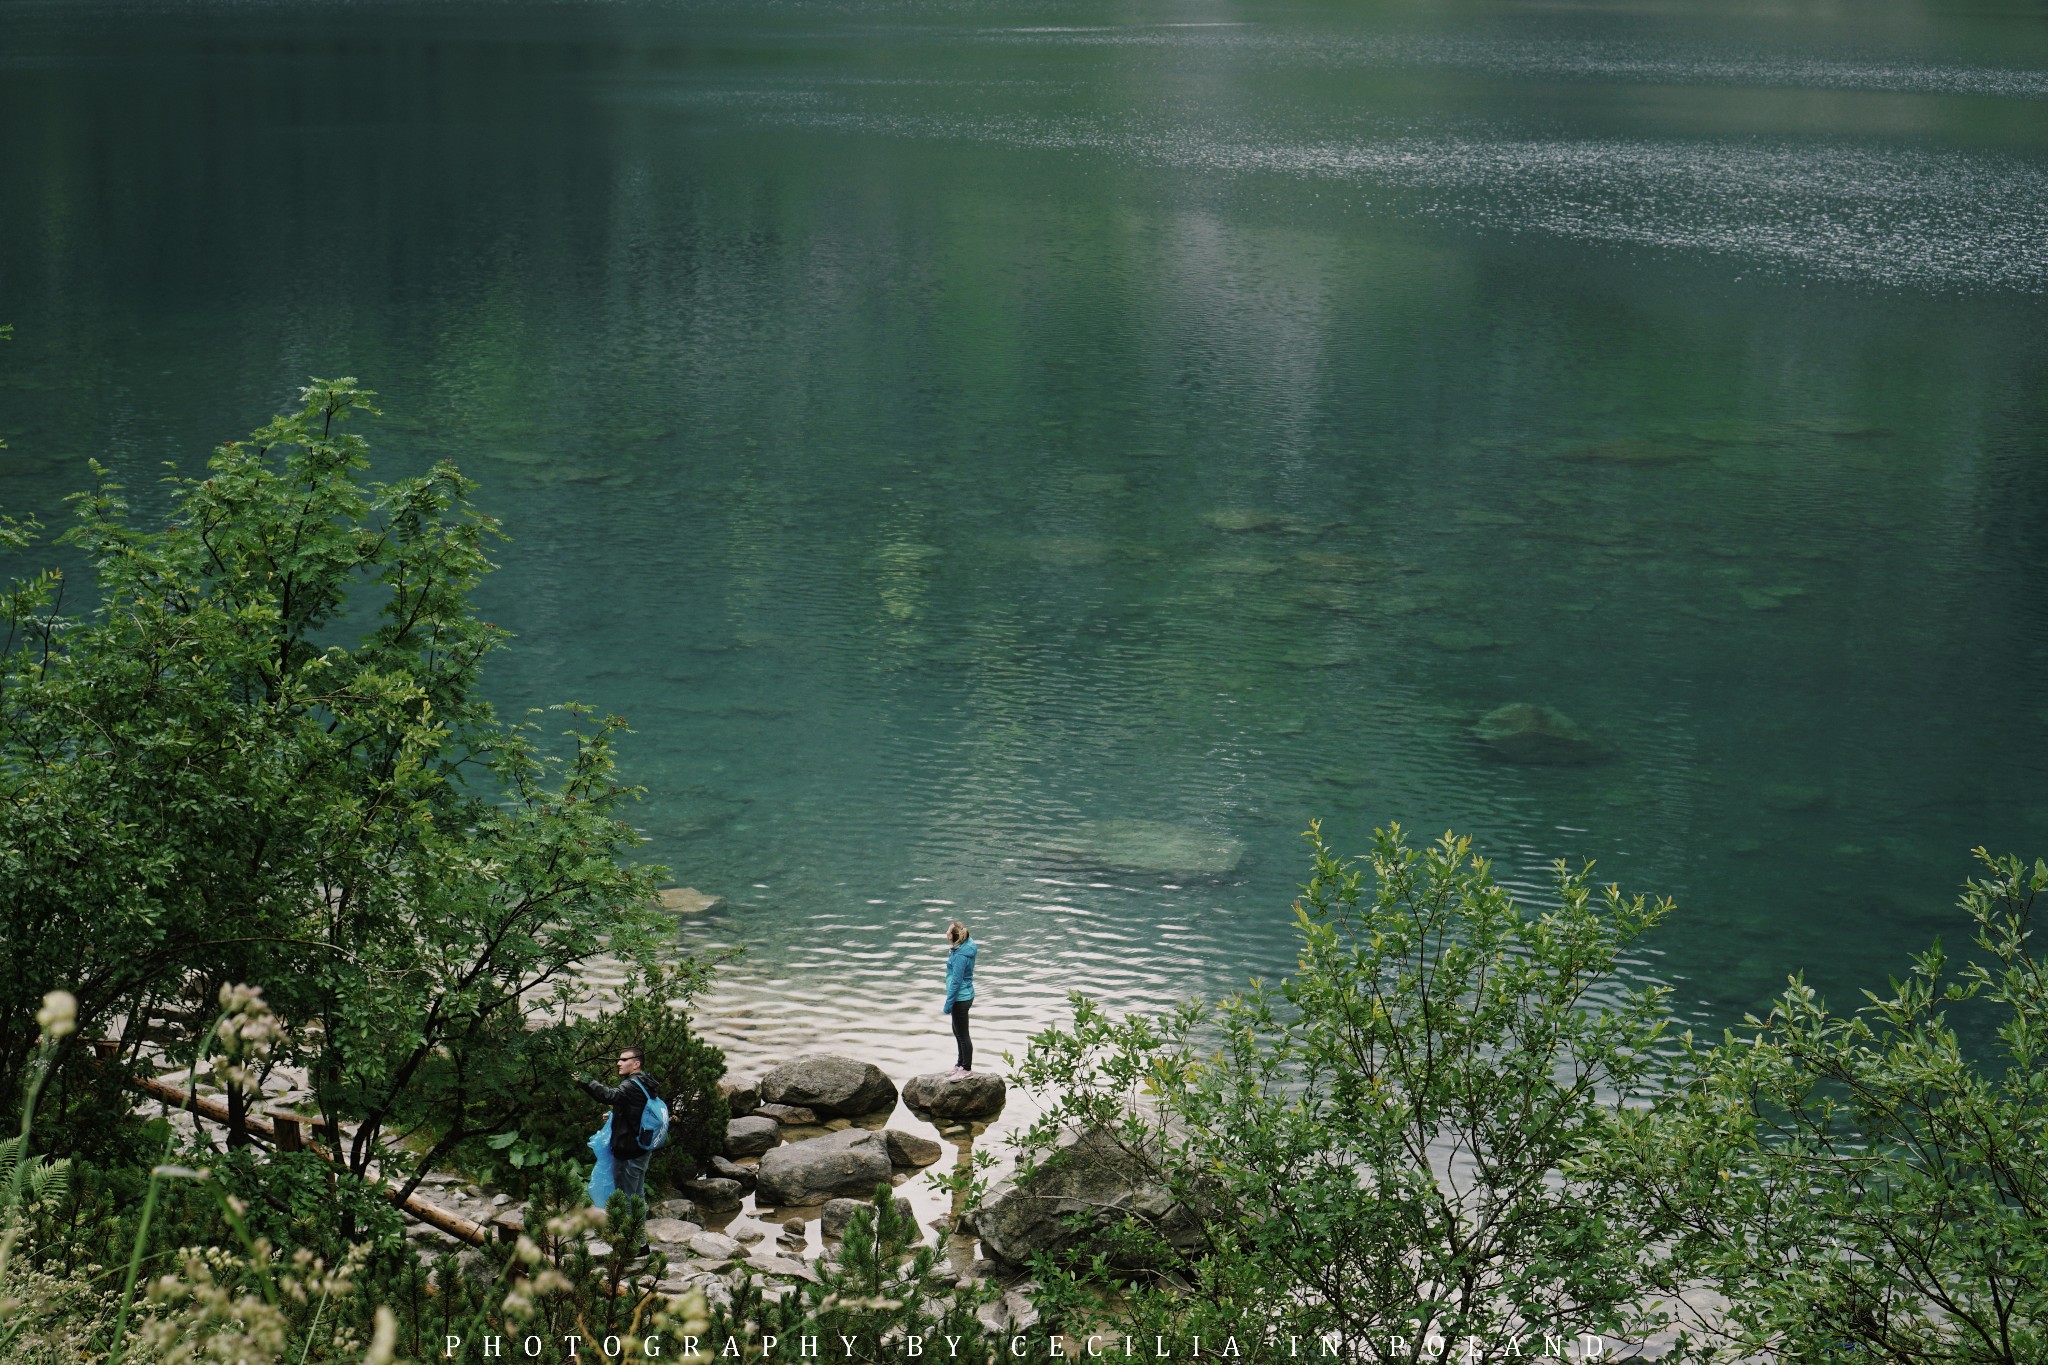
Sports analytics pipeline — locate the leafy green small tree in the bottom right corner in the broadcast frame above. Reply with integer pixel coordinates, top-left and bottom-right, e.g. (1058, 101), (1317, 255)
(1610, 849), (2048, 1365)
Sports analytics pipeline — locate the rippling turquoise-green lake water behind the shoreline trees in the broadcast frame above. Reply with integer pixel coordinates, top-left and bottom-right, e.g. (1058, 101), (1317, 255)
(0, 0), (2048, 1074)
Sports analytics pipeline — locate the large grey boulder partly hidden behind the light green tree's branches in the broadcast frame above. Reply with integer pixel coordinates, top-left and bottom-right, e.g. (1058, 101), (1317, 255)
(973, 1132), (1202, 1273)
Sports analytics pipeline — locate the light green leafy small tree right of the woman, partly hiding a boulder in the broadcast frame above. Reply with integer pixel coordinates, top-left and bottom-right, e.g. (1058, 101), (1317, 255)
(1022, 827), (1669, 1361)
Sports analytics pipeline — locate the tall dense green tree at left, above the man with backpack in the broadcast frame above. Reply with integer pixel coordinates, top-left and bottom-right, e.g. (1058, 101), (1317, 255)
(0, 379), (688, 1189)
